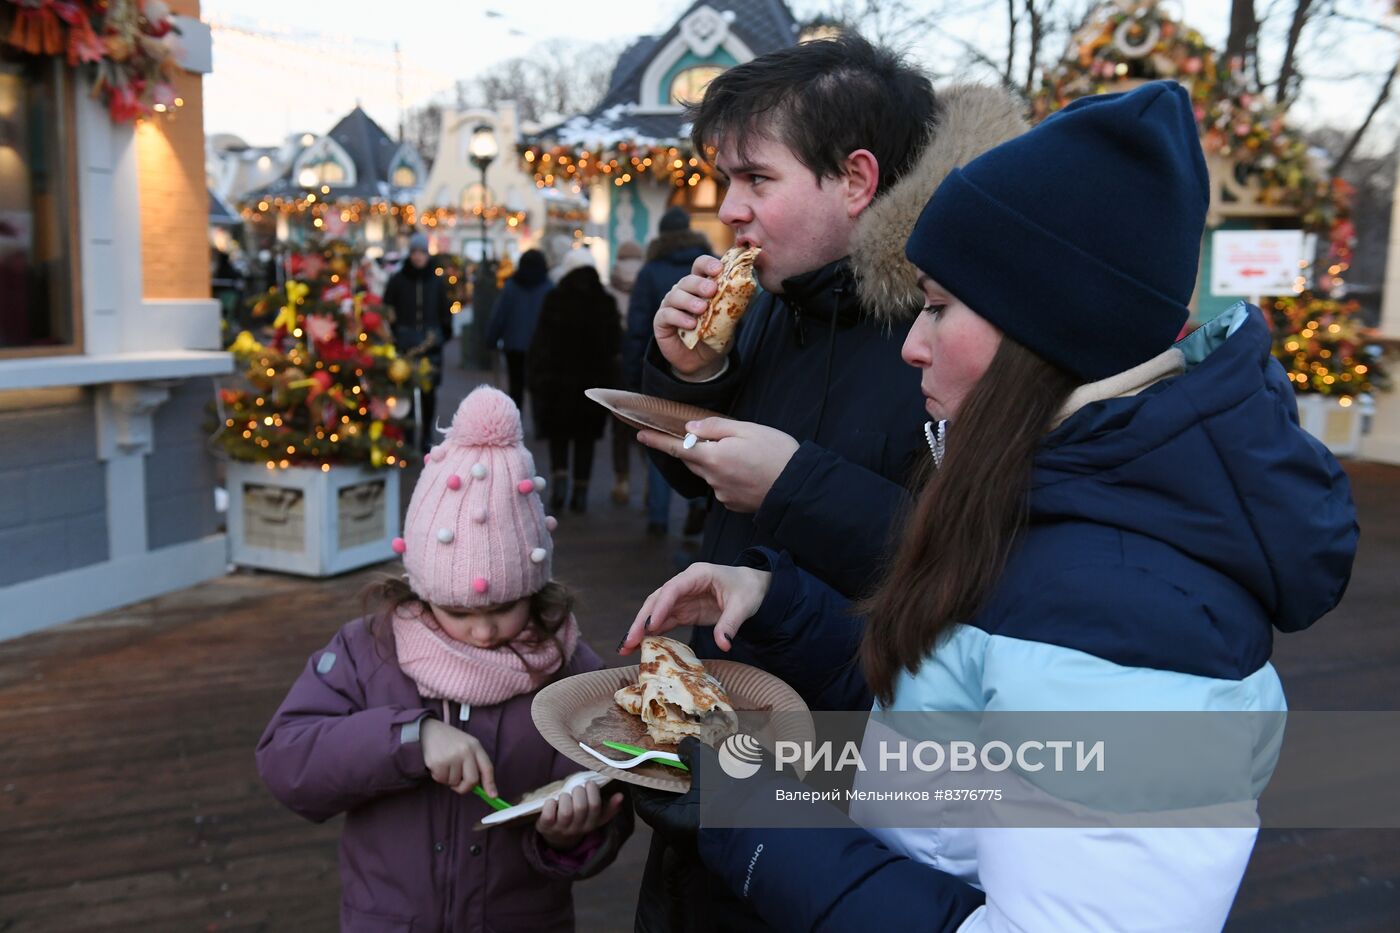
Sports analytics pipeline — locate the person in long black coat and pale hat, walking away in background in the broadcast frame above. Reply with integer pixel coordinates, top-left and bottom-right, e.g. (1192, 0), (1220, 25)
(529, 249), (622, 513)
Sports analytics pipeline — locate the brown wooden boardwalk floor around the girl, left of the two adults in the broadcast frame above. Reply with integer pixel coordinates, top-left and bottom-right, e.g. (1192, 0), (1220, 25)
(0, 465), (679, 933)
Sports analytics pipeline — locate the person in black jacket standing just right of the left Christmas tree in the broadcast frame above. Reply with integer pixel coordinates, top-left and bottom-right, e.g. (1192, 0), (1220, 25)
(384, 233), (452, 450)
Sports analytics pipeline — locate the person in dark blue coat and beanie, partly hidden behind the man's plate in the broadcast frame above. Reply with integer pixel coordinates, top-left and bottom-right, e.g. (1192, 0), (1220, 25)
(623, 207), (711, 537)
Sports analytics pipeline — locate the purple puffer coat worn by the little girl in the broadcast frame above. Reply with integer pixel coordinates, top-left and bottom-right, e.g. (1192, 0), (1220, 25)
(258, 619), (633, 933)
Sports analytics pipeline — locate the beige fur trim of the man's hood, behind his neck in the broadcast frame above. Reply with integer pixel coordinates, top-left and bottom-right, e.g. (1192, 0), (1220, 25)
(851, 84), (1028, 324)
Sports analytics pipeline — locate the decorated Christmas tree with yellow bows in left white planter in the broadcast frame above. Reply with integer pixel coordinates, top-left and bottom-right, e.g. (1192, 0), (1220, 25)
(217, 244), (431, 471)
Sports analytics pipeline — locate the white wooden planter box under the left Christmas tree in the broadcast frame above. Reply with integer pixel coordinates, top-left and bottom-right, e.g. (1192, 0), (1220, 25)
(228, 461), (399, 577)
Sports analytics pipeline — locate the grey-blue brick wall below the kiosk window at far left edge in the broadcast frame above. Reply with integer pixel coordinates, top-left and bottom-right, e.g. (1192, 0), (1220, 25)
(0, 389), (108, 587)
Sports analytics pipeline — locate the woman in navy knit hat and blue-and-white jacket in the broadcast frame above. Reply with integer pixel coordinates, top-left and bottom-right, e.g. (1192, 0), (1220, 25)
(620, 81), (1357, 930)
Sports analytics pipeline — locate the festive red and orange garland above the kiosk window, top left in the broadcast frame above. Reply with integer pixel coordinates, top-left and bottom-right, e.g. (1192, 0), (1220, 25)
(0, 0), (185, 123)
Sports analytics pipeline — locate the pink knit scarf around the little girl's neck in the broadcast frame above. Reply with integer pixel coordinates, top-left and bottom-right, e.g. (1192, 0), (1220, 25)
(393, 609), (578, 706)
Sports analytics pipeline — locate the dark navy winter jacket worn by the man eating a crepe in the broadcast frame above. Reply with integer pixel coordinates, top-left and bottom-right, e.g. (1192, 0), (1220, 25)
(643, 261), (927, 627)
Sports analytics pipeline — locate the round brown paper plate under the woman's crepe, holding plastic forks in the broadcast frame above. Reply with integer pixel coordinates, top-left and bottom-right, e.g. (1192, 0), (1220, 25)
(531, 660), (816, 793)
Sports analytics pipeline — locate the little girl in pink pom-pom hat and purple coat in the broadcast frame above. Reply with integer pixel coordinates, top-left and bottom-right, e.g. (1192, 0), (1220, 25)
(258, 387), (631, 930)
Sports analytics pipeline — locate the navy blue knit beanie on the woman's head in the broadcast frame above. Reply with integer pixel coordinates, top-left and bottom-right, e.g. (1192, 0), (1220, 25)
(904, 81), (1210, 381)
